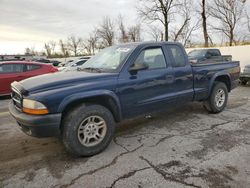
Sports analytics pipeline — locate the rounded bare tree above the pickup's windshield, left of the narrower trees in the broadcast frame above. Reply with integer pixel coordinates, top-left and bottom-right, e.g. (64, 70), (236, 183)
(97, 17), (115, 47)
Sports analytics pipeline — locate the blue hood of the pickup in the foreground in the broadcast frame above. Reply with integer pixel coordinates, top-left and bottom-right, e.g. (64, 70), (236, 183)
(20, 71), (118, 92)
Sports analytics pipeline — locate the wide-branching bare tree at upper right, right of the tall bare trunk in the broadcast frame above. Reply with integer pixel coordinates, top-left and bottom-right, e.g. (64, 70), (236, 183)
(209, 0), (245, 46)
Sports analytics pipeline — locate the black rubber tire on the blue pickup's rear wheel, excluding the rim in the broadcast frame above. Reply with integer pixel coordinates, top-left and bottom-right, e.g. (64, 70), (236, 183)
(203, 82), (228, 113)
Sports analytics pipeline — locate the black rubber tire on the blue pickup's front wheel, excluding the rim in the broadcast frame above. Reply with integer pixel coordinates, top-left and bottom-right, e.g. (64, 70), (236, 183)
(62, 104), (115, 157)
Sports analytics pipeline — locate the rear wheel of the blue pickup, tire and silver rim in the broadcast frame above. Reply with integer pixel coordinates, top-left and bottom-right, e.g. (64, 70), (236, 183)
(203, 82), (228, 113)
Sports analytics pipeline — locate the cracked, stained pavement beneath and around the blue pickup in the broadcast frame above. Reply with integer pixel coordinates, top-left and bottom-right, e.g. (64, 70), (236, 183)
(0, 87), (250, 188)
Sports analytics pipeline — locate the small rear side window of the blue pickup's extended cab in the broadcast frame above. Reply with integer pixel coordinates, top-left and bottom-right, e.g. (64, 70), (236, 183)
(169, 45), (186, 67)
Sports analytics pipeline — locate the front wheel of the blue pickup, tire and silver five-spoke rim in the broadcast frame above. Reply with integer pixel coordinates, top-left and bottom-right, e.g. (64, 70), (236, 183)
(63, 105), (115, 156)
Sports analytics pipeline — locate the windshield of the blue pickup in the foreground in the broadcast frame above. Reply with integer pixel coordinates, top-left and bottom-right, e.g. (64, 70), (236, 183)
(81, 45), (134, 72)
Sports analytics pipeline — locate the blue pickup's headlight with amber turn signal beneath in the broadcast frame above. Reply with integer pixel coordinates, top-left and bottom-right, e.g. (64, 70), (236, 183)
(23, 99), (49, 115)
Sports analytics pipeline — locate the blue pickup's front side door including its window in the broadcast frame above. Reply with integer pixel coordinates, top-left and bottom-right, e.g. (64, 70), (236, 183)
(118, 46), (175, 117)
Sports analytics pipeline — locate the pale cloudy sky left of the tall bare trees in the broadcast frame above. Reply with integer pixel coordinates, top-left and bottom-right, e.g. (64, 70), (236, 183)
(0, 0), (137, 54)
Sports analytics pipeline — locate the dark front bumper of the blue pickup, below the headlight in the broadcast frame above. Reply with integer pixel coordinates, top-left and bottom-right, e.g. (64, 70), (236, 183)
(9, 102), (62, 137)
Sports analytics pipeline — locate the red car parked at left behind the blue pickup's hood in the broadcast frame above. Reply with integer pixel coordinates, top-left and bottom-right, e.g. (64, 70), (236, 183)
(0, 61), (58, 96)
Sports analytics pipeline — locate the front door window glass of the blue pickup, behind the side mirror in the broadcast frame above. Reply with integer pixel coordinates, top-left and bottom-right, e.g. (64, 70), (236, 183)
(135, 48), (166, 69)
